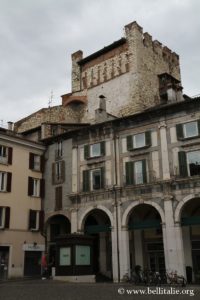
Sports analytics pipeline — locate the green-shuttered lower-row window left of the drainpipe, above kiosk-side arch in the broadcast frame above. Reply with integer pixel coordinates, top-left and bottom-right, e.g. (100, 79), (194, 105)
(83, 167), (104, 192)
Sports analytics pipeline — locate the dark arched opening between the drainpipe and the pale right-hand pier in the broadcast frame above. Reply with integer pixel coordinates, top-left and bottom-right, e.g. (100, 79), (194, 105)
(128, 204), (165, 273)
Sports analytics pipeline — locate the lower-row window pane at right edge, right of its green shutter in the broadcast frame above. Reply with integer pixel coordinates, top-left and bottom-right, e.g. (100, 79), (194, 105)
(187, 151), (200, 176)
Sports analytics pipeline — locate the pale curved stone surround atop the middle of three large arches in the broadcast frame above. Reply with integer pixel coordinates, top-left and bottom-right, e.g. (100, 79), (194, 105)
(122, 200), (165, 227)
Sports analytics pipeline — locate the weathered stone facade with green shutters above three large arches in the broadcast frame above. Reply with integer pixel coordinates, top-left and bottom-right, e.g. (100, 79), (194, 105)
(45, 99), (200, 281)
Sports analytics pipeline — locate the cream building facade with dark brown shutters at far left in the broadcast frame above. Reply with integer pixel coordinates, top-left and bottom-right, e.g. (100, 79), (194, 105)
(0, 128), (45, 279)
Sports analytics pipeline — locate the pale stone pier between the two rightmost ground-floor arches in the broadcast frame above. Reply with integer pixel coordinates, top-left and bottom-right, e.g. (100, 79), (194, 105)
(162, 196), (185, 275)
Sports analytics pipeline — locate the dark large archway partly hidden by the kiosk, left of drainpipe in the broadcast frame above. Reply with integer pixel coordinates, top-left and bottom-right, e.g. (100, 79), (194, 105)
(84, 209), (112, 281)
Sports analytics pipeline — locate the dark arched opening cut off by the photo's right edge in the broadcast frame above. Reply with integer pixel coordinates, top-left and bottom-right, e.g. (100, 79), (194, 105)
(181, 198), (200, 283)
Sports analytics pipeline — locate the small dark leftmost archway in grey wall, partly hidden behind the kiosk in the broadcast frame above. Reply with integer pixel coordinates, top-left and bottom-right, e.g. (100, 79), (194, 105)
(46, 215), (71, 266)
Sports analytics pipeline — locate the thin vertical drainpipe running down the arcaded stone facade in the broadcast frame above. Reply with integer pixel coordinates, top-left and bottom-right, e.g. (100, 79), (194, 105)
(113, 132), (120, 282)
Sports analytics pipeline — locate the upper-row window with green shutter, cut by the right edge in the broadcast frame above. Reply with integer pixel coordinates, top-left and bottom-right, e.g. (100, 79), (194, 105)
(176, 121), (200, 140)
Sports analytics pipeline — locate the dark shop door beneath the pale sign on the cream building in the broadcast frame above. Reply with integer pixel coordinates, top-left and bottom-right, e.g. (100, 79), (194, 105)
(24, 251), (42, 276)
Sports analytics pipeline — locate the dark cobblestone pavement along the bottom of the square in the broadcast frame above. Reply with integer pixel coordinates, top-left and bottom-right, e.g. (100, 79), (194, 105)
(0, 280), (200, 300)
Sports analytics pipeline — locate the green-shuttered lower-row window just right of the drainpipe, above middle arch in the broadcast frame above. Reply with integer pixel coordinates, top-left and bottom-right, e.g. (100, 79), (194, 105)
(125, 159), (147, 185)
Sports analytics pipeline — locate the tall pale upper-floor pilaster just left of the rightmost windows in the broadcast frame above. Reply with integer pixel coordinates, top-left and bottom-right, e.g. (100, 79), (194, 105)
(159, 122), (170, 180)
